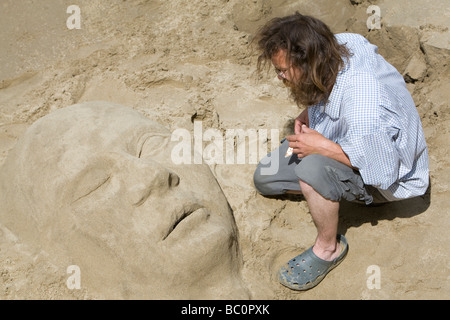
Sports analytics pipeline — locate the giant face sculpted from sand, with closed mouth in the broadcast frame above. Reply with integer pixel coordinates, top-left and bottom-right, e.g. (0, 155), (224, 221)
(0, 102), (250, 299)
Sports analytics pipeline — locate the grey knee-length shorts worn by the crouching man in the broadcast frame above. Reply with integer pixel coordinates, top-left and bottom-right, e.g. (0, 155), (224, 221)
(253, 140), (388, 205)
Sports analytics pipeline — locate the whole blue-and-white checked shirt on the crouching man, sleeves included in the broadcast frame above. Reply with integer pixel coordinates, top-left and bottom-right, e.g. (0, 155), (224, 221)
(308, 33), (429, 201)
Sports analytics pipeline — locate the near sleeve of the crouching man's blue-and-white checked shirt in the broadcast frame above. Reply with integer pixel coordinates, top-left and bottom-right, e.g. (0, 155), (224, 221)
(338, 73), (400, 190)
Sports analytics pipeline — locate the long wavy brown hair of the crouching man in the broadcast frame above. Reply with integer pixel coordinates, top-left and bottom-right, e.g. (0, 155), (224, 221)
(254, 12), (350, 106)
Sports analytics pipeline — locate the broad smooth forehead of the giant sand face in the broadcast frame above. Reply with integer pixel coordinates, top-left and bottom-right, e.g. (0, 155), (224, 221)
(11, 102), (170, 175)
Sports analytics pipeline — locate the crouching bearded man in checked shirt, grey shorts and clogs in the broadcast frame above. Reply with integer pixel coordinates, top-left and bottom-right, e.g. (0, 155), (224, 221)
(254, 13), (429, 290)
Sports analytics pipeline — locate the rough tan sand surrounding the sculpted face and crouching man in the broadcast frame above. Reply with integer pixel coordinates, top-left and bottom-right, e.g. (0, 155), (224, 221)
(0, 0), (450, 300)
